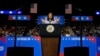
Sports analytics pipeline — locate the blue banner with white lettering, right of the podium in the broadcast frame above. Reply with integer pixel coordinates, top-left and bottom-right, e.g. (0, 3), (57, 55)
(59, 36), (97, 56)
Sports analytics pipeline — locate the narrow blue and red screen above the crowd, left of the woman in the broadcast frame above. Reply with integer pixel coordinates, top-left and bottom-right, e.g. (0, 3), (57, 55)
(8, 15), (30, 21)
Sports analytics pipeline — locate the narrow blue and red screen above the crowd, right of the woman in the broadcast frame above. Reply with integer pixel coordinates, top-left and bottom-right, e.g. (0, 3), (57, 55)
(72, 16), (93, 21)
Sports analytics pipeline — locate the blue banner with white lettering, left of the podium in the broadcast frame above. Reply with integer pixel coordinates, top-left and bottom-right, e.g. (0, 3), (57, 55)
(0, 37), (42, 56)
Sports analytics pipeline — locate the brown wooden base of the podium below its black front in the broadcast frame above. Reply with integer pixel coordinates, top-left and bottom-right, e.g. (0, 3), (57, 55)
(42, 37), (59, 56)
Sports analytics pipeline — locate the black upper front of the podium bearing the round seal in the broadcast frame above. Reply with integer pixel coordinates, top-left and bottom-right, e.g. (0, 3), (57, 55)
(39, 24), (62, 37)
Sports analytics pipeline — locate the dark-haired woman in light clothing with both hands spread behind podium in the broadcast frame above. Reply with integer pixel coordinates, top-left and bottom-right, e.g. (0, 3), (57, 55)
(41, 12), (60, 24)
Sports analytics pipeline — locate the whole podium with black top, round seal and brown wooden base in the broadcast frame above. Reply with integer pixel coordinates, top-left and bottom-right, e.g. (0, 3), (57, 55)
(39, 24), (61, 56)
